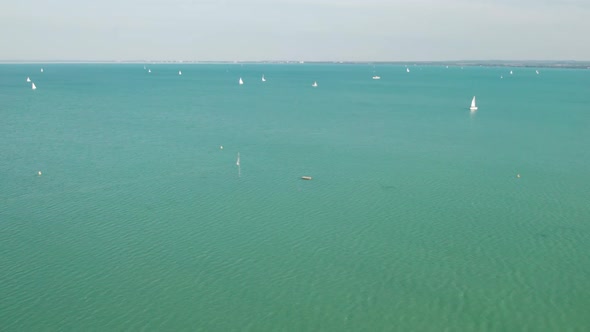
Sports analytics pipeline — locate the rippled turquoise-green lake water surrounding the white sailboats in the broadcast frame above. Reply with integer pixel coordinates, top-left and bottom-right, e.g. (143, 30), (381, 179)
(0, 64), (590, 331)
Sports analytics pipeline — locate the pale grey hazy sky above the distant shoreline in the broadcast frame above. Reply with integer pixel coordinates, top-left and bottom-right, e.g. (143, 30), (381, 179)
(0, 0), (590, 61)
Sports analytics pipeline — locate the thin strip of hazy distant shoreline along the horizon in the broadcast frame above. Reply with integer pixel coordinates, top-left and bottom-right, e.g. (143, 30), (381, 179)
(0, 60), (590, 69)
